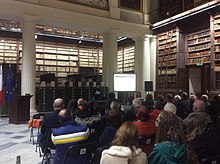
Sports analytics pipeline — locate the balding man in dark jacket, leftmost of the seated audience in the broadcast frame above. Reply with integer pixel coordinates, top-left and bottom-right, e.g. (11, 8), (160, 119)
(39, 98), (64, 153)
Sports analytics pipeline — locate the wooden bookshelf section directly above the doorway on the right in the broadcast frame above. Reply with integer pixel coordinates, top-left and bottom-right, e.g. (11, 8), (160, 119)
(187, 29), (211, 65)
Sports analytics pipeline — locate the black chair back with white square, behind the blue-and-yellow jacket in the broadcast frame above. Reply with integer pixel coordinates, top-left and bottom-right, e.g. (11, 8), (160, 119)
(62, 142), (97, 164)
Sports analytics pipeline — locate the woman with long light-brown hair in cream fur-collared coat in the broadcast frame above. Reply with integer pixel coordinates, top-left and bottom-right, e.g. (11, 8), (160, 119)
(100, 122), (147, 164)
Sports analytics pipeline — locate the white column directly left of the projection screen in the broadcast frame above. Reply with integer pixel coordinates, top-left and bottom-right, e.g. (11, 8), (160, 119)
(102, 30), (117, 91)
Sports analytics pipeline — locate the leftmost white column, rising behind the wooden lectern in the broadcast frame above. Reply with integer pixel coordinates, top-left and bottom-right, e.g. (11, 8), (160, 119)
(21, 16), (36, 113)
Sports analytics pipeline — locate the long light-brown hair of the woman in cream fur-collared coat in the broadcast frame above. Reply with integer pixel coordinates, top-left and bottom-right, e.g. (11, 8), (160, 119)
(112, 121), (138, 154)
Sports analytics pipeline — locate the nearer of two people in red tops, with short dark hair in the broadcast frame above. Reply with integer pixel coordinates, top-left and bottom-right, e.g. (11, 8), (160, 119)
(134, 105), (156, 156)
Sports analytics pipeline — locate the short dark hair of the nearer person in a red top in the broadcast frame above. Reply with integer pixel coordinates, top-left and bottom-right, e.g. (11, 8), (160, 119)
(135, 105), (150, 122)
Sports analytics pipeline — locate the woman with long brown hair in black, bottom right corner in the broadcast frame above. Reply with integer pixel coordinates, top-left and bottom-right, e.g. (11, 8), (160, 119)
(185, 112), (220, 162)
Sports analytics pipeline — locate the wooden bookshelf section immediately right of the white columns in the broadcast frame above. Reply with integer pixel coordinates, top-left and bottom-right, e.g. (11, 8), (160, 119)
(157, 29), (177, 90)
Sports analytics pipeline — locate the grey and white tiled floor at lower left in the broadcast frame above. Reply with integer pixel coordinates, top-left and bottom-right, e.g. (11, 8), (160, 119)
(0, 118), (41, 164)
